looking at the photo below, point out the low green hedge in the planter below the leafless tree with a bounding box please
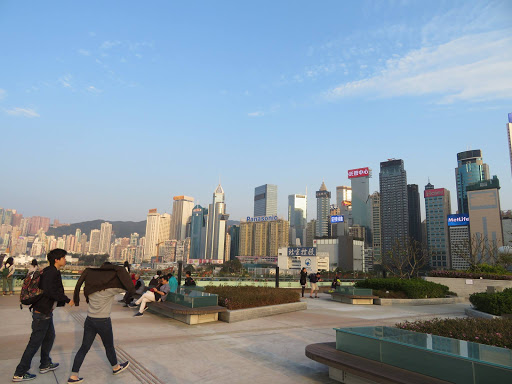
[355,278,449,299]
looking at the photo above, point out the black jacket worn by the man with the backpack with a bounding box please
[32,265,71,316]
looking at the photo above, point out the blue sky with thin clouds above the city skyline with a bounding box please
[0,0,512,223]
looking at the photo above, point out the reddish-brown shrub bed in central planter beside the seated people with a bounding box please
[205,285,300,309]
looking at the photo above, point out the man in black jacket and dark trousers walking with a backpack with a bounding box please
[12,248,74,382]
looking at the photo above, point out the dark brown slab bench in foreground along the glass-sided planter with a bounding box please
[306,342,449,384]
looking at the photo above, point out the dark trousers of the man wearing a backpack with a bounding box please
[14,312,55,376]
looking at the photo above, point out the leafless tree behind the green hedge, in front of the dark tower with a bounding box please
[382,237,430,279]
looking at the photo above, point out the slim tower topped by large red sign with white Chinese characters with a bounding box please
[348,167,372,240]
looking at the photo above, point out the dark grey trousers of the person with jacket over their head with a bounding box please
[71,316,117,376]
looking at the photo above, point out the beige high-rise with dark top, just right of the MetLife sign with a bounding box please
[467,176,503,261]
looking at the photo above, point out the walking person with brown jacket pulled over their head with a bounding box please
[68,262,135,384]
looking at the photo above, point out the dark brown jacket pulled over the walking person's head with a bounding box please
[73,263,135,307]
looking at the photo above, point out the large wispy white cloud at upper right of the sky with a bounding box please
[326,29,512,103]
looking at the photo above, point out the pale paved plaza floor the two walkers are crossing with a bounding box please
[0,293,470,384]
